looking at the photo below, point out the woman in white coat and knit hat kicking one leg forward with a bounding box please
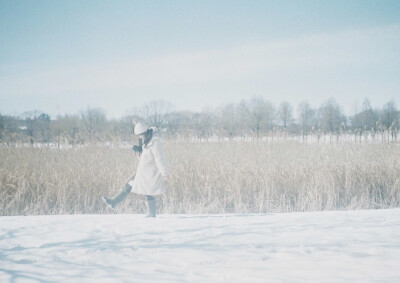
[102,122,168,217]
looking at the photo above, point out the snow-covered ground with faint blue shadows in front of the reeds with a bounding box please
[0,209,400,282]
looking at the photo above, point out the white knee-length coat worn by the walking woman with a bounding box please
[129,135,168,195]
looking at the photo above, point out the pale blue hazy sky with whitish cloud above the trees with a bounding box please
[0,0,400,118]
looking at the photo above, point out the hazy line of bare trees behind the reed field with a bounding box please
[0,97,400,146]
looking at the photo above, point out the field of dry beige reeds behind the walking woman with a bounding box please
[0,142,400,215]
